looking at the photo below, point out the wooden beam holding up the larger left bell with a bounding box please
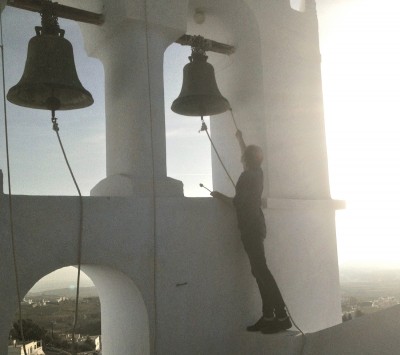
[7,0,104,25]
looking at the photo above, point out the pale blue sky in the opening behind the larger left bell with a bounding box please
[0,6,105,195]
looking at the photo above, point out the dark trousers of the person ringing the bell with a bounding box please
[241,232,286,317]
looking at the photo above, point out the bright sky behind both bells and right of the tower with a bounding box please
[0,0,400,292]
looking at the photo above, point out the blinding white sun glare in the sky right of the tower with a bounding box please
[320,0,400,266]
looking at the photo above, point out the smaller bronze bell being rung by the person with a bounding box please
[171,52,230,116]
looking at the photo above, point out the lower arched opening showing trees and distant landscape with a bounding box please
[10,267,101,354]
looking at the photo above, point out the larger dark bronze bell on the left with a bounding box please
[7,23,93,111]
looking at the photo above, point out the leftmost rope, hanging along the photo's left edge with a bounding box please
[0,10,27,355]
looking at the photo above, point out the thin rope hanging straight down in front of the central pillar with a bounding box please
[144,0,158,355]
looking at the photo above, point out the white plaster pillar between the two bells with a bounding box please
[76,0,186,196]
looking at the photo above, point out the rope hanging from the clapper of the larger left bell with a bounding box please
[51,111,83,355]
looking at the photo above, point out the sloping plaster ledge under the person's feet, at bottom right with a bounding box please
[231,306,400,355]
